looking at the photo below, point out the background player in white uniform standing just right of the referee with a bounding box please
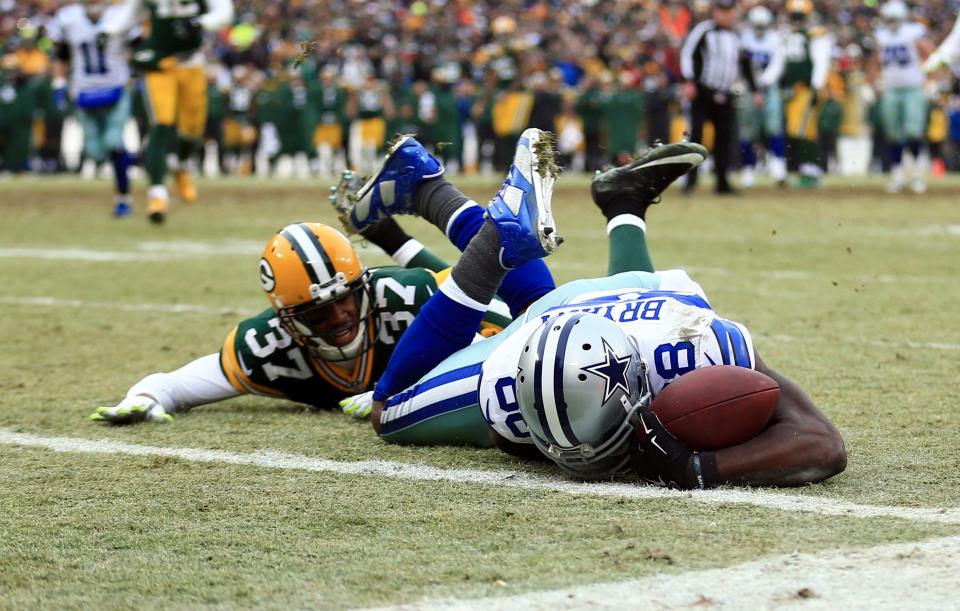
[740,5,787,187]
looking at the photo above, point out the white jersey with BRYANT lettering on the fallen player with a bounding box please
[479,281,756,443]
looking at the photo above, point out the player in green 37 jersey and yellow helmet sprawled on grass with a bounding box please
[90,216,510,424]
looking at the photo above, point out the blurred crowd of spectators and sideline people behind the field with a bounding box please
[0,0,960,179]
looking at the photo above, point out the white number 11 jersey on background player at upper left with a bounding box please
[55,4,130,99]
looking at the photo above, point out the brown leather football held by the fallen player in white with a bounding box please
[650,365,780,450]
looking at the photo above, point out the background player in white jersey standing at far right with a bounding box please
[870,0,933,193]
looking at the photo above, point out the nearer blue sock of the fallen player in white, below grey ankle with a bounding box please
[373,290,484,401]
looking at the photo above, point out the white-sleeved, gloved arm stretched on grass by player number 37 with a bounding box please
[90,353,241,424]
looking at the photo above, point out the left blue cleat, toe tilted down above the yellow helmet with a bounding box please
[341,135,443,233]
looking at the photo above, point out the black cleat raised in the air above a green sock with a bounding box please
[590,142,707,218]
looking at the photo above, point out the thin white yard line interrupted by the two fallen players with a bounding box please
[7,295,960,350]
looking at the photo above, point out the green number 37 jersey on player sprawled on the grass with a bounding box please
[220,266,503,408]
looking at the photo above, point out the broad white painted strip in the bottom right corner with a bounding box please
[372,536,960,611]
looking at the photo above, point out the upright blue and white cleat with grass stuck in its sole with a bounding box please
[487,128,563,269]
